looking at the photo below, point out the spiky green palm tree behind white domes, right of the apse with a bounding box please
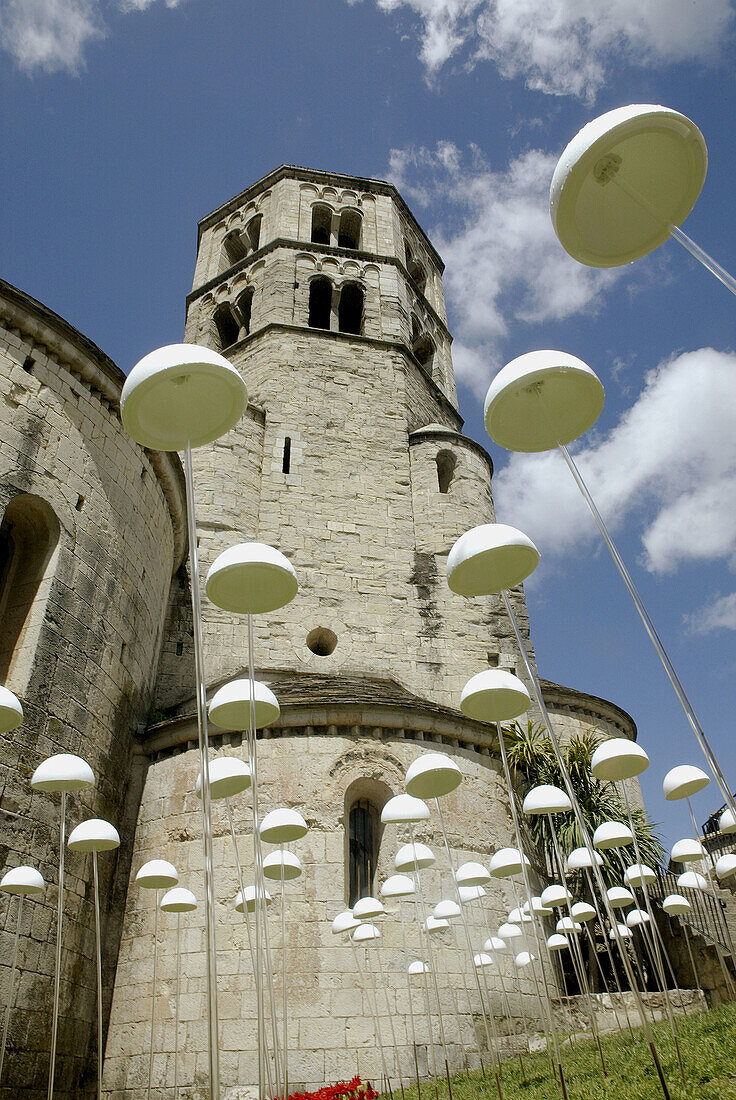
[503,722,664,886]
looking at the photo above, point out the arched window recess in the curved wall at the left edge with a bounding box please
[0,493,61,690]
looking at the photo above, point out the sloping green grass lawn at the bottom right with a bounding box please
[384,1004,736,1100]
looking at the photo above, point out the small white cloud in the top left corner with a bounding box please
[0,0,101,73]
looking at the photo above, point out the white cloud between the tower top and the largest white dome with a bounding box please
[389,142,620,396]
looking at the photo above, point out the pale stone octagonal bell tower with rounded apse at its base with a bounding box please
[106,166,631,1095]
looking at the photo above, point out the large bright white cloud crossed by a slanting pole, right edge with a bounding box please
[494,348,736,573]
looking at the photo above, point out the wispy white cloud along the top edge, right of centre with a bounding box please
[365,0,734,100]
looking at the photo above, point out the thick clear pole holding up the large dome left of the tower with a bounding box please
[182,443,220,1100]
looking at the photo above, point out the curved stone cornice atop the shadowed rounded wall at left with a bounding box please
[0,279,186,571]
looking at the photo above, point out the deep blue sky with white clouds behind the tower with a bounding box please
[0,0,736,840]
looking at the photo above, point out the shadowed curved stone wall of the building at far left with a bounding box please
[0,284,184,1096]
